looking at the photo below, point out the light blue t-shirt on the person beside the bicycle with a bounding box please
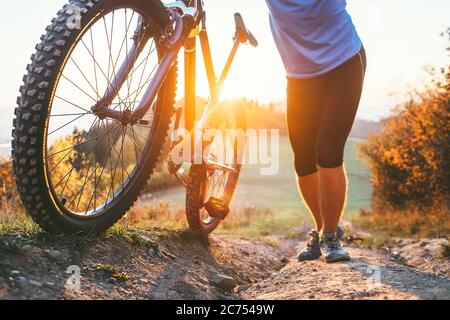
[266,0,362,78]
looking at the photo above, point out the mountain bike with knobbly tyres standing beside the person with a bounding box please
[12,0,258,235]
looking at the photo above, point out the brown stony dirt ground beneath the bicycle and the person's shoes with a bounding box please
[0,230,450,300]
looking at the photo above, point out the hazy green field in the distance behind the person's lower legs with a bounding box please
[146,137,371,219]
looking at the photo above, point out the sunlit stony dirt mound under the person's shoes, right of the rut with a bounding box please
[241,242,450,299]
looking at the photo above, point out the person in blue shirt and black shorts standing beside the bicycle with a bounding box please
[266,0,366,262]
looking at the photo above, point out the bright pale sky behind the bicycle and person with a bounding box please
[0,0,450,120]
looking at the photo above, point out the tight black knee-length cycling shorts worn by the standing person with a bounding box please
[287,49,366,176]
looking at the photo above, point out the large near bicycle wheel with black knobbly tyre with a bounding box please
[12,0,177,234]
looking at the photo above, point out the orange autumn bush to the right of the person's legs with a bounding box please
[360,32,450,235]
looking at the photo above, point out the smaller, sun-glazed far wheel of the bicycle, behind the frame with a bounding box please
[186,105,246,237]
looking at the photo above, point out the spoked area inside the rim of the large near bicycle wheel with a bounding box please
[45,8,160,216]
